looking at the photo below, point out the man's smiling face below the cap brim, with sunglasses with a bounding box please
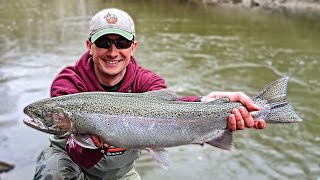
[87,34,137,79]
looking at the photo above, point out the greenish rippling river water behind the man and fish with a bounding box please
[0,0,320,180]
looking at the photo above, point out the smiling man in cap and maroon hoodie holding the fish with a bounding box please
[34,9,265,179]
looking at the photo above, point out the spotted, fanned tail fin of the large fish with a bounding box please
[253,77,302,123]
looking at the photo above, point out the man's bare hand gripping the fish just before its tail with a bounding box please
[201,92,266,131]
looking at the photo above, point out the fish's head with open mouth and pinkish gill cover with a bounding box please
[23,101,73,135]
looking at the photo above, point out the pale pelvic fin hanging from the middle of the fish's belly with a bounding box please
[147,148,169,170]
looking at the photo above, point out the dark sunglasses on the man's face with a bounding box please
[94,38,133,49]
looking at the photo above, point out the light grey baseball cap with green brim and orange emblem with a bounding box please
[89,8,135,42]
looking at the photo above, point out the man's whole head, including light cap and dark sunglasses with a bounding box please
[87,10,137,86]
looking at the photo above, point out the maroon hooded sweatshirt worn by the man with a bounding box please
[51,52,199,169]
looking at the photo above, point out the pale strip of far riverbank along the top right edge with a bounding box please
[186,0,320,16]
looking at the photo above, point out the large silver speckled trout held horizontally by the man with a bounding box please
[24,77,301,167]
